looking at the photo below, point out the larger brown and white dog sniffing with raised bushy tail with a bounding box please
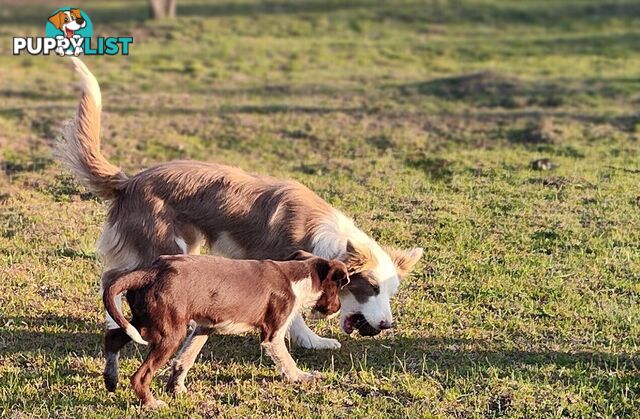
[57,58,422,394]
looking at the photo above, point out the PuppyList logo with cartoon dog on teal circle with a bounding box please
[13,7,133,57]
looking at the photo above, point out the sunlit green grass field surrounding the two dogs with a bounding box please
[0,0,640,418]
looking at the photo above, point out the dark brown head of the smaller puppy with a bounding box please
[291,250,349,317]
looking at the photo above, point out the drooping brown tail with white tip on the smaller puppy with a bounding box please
[102,268,157,345]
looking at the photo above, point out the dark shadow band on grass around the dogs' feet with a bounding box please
[0,315,640,388]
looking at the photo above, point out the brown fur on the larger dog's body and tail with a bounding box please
[57,58,424,394]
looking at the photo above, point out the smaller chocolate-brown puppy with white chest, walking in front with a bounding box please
[103,252,349,408]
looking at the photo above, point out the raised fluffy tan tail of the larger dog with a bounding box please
[55,57,127,199]
